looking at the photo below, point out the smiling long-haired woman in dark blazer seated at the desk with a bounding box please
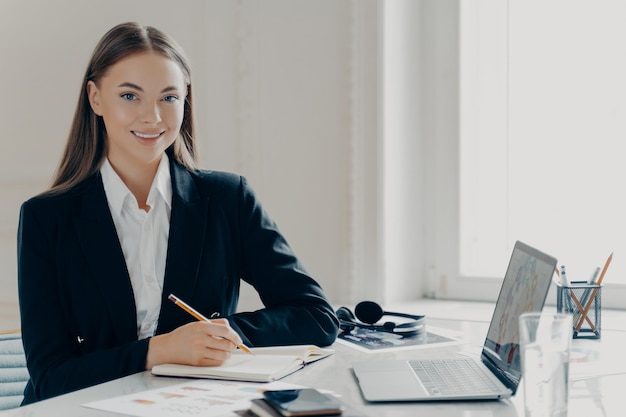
[18,23,338,403]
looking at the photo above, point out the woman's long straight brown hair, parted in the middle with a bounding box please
[48,22,196,193]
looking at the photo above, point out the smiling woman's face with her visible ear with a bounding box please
[87,52,187,170]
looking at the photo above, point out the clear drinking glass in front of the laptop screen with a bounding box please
[519,313,573,417]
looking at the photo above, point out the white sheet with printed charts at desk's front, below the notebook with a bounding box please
[83,380,302,417]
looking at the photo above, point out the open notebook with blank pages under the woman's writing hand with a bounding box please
[152,345,335,382]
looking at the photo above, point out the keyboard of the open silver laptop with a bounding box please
[409,358,497,395]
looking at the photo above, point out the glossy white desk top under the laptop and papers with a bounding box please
[0,301,626,417]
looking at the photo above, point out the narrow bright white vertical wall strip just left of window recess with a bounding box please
[382,0,424,299]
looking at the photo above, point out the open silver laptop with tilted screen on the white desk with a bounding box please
[352,241,557,402]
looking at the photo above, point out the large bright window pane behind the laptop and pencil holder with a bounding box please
[447,0,626,305]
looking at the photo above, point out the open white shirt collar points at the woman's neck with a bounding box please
[100,153,172,214]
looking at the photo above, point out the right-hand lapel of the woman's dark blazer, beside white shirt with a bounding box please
[159,162,209,318]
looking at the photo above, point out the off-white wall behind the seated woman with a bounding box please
[0,0,398,324]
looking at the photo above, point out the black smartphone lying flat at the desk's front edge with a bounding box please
[263,388,343,417]
